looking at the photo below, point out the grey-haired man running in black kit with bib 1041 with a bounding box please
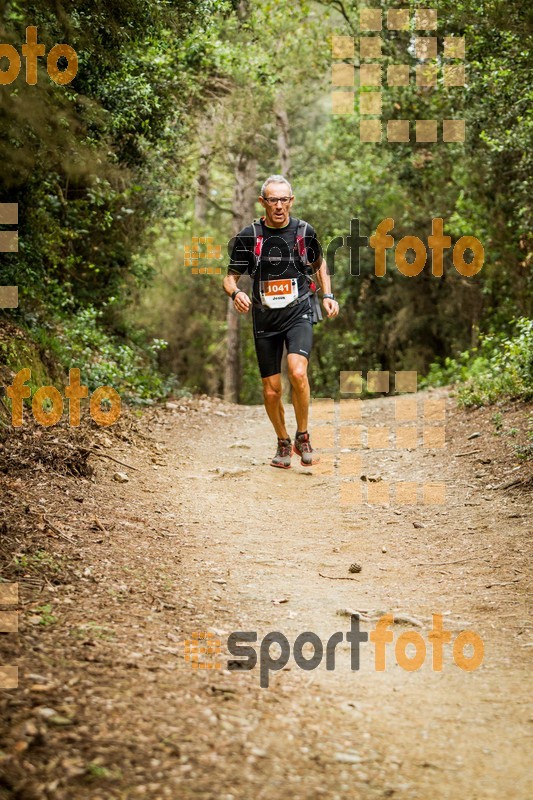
[224,175,339,469]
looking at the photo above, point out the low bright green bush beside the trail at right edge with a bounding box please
[423,318,533,406]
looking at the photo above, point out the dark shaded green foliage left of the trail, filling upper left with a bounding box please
[0,0,232,402]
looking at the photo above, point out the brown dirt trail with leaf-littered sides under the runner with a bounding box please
[0,390,533,800]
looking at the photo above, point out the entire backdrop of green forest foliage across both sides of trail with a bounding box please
[0,0,533,403]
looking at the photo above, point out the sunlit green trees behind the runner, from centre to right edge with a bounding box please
[129,0,533,402]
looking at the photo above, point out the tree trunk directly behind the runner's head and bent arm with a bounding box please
[224,153,257,403]
